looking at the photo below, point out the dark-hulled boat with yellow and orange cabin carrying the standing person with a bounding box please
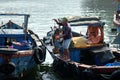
[44,17,120,80]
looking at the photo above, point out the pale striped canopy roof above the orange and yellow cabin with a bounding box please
[58,16,105,27]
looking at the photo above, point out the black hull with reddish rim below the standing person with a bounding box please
[53,57,120,80]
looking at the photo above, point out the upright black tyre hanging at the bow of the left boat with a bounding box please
[33,47,45,64]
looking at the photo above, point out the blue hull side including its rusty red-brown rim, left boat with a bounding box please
[0,50,36,76]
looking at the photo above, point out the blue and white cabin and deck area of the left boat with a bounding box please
[0,14,33,50]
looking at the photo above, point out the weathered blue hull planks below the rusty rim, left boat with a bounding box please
[0,56,37,78]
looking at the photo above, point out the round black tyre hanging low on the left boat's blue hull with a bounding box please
[0,62,16,74]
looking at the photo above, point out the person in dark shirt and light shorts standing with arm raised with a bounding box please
[53,17,72,60]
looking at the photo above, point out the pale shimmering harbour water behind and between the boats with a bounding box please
[0,0,118,80]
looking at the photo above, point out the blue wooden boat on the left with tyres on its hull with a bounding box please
[0,13,46,80]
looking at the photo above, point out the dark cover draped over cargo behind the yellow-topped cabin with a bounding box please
[91,47,115,65]
